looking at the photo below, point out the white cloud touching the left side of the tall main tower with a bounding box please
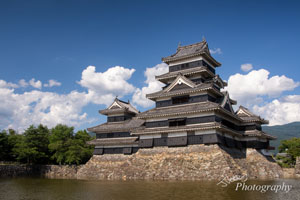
[132,63,168,108]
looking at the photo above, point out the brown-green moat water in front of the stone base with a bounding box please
[0,178,300,200]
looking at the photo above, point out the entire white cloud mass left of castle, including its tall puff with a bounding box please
[0,66,135,131]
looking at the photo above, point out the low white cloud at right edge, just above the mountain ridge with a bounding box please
[253,95,300,125]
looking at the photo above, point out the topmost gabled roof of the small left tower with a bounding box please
[99,98,139,115]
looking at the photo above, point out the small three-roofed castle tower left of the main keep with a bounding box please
[88,98,144,155]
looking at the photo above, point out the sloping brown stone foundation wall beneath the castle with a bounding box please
[77,145,283,180]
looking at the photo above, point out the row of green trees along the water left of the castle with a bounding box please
[0,124,93,164]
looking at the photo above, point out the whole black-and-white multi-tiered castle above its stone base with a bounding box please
[88,40,276,155]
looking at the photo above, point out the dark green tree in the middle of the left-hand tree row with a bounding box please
[14,125,49,164]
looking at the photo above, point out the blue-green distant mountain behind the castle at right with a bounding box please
[262,122,300,153]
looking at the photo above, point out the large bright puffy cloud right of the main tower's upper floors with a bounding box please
[225,69,299,107]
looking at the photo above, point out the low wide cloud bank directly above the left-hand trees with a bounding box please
[0,88,89,131]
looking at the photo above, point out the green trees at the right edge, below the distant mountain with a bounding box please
[277,138,300,167]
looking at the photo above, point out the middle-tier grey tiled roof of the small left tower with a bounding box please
[88,118,144,133]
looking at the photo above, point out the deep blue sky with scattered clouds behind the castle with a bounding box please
[0,0,300,132]
